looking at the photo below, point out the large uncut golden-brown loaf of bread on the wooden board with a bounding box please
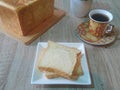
[0,0,54,36]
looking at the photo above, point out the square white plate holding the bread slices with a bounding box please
[31,42,92,85]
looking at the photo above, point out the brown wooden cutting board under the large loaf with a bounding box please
[0,9,65,45]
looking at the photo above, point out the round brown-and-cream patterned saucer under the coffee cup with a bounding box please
[75,22,116,45]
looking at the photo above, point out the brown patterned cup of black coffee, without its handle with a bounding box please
[89,9,113,38]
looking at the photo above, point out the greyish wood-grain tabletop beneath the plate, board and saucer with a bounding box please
[0,0,120,90]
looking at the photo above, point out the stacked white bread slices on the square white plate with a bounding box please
[37,41,83,80]
